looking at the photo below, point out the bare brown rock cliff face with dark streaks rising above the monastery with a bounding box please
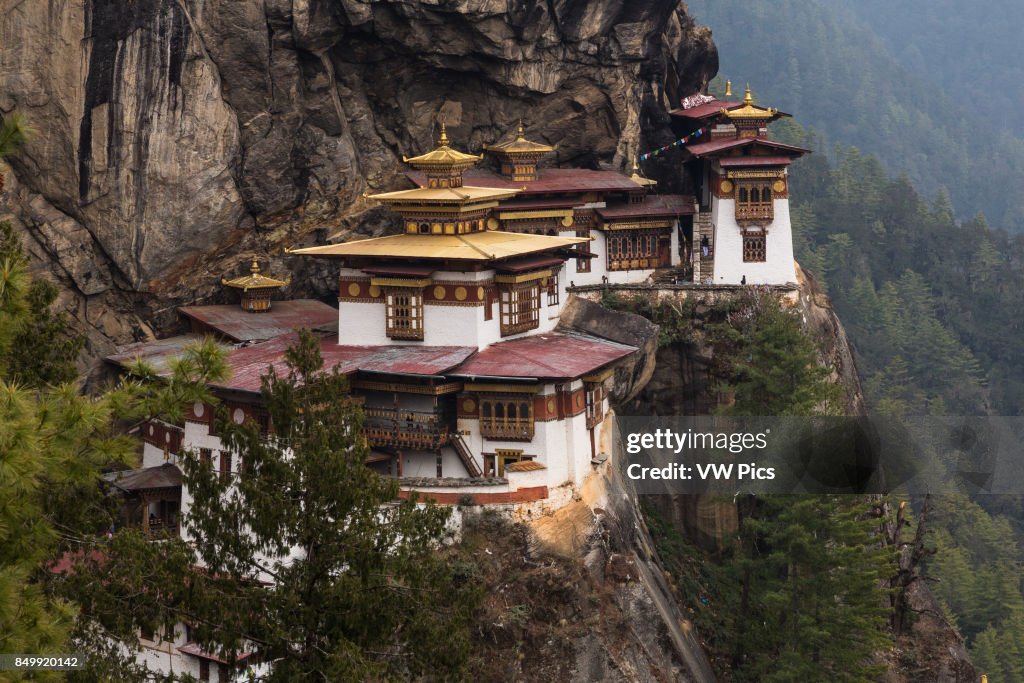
[0,0,718,374]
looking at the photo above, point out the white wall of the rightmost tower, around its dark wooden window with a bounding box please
[711,197,797,285]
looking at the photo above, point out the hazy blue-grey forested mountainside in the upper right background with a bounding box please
[687,0,1024,232]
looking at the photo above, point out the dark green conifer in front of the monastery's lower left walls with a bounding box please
[78,331,478,681]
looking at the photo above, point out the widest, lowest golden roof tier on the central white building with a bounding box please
[289,230,590,261]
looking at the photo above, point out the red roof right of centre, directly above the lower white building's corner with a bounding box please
[450,332,637,380]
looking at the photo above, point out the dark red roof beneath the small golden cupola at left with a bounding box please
[178,299,338,342]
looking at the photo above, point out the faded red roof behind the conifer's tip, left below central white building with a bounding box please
[218,334,476,393]
